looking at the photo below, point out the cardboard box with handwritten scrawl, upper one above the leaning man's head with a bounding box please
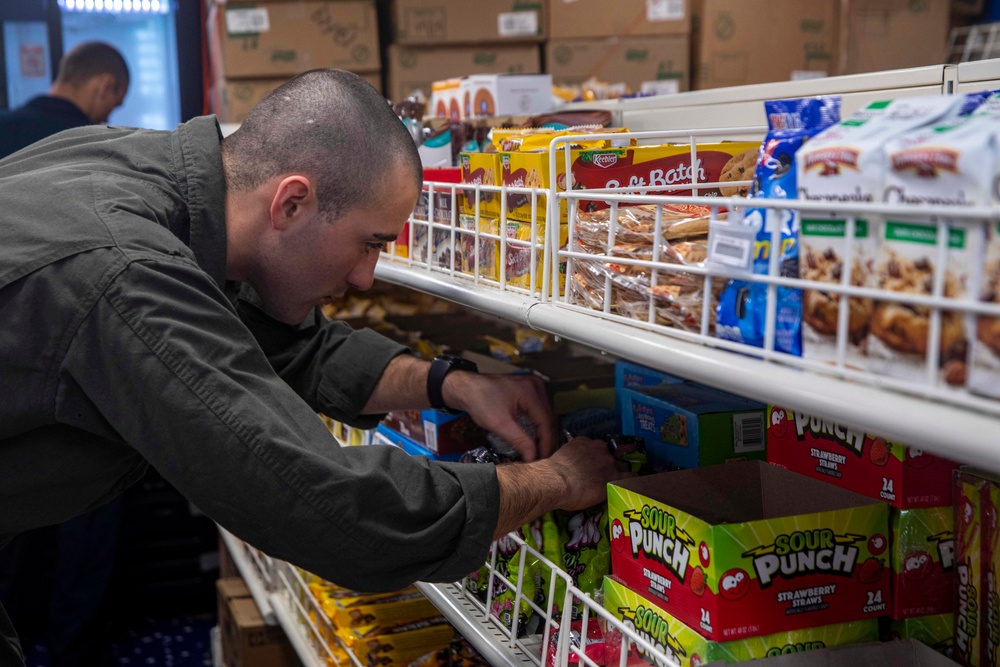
[209,0,381,79]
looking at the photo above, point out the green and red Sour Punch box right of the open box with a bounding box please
[889,505,955,619]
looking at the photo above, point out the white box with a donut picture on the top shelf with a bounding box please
[460,74,552,118]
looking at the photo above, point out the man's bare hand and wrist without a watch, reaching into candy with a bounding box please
[493,438,635,539]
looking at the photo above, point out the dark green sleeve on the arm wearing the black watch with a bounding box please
[236,284,407,428]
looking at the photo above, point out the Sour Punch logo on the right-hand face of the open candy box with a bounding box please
[743,528,865,588]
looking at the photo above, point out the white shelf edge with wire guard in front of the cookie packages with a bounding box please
[376,151,1000,471]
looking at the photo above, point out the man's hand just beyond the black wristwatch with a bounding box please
[442,371,556,461]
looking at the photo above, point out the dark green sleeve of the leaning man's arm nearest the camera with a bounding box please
[57,260,499,590]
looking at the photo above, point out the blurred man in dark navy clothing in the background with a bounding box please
[0,37,129,667]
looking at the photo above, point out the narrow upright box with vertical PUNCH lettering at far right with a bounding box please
[955,469,990,667]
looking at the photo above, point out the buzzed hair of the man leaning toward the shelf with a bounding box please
[222,69,423,221]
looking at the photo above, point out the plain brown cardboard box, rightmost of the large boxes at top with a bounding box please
[837,0,949,74]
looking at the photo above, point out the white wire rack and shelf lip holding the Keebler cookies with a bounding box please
[376,127,1000,471]
